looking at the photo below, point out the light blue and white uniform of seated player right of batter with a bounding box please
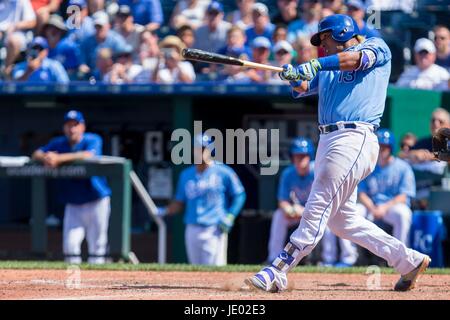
[358,158,416,244]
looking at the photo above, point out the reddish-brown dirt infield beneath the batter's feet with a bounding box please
[0,270,450,300]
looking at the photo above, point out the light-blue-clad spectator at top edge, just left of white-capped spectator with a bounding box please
[67,0,95,44]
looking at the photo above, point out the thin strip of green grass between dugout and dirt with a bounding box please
[0,261,450,274]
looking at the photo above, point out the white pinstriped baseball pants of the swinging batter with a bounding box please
[273,123,425,274]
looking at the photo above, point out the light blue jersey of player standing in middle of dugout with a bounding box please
[175,162,244,226]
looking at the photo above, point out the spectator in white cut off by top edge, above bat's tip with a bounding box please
[170,0,210,30]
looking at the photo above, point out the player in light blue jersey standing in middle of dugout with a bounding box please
[158,135,246,266]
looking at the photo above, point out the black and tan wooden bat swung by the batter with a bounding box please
[181,48,283,72]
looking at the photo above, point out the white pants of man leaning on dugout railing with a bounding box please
[63,197,111,264]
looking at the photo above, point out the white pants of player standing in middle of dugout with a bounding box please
[185,224,227,266]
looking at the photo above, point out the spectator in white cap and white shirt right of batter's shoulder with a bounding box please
[396,38,450,90]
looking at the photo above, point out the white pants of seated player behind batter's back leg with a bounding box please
[357,203,412,245]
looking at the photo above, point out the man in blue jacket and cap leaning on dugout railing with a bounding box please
[32,110,111,264]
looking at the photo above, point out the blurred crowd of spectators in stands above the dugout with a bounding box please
[0,0,450,90]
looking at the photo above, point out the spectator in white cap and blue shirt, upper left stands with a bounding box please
[80,11,126,74]
